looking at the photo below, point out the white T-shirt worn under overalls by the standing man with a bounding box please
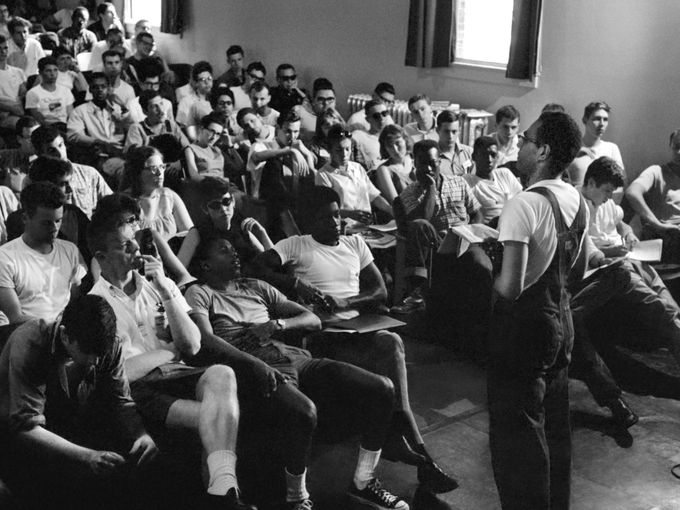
[498,179,588,291]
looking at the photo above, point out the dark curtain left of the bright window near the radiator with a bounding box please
[406,0,456,67]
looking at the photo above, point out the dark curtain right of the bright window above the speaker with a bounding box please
[505,0,542,80]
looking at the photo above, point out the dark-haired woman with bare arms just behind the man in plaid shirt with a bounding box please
[375,124,416,204]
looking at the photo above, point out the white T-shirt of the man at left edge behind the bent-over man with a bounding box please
[0,237,87,322]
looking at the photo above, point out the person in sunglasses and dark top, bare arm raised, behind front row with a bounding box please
[178,177,274,274]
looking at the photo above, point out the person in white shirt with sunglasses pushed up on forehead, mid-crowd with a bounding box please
[315,125,392,228]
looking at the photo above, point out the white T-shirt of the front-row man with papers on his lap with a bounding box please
[274,235,373,316]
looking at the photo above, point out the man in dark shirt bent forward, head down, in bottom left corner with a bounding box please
[0,295,157,509]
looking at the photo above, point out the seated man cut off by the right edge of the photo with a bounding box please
[626,129,680,264]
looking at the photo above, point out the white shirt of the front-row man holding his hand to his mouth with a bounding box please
[90,271,191,360]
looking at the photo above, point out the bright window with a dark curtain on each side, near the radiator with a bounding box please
[454,0,513,69]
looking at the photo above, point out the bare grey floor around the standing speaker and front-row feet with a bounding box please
[309,334,680,510]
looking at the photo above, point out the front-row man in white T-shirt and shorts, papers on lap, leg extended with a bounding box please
[259,187,458,493]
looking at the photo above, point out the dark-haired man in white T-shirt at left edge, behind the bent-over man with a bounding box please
[0,182,86,324]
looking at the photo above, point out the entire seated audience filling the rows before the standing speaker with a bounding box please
[0,0,680,510]
